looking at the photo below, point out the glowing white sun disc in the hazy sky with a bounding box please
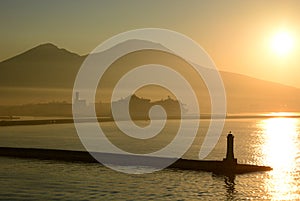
[271,31,295,56]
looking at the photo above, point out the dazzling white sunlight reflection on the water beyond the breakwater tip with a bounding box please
[259,117,300,200]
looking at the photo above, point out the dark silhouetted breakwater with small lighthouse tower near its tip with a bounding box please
[0,133,272,175]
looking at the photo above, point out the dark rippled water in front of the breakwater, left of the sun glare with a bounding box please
[0,158,270,200]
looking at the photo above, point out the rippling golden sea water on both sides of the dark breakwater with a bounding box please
[0,114,300,200]
